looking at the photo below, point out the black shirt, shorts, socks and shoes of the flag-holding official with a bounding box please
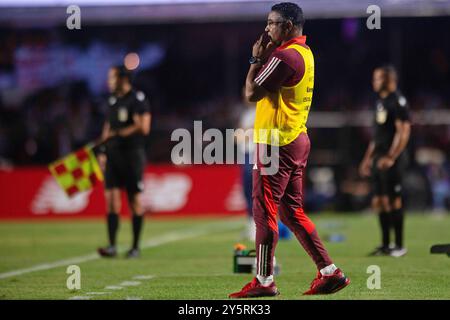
[98,90,151,258]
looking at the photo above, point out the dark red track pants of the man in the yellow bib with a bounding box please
[253,133,332,276]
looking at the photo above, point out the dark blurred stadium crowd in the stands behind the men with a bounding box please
[0,17,450,211]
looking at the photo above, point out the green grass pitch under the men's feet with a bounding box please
[0,214,450,300]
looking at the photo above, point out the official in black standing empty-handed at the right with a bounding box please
[359,66,411,257]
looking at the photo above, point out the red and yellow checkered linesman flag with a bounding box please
[48,144,103,197]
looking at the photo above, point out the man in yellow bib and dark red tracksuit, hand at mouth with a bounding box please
[230,2,350,298]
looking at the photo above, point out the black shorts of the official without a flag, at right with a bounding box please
[372,155,407,199]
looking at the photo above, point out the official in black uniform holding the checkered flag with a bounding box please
[98,66,151,258]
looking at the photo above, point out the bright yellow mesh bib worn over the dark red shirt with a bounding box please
[253,44,314,146]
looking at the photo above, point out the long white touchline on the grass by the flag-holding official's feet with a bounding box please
[0,221,242,279]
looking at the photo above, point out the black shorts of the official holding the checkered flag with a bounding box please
[105,148,145,194]
